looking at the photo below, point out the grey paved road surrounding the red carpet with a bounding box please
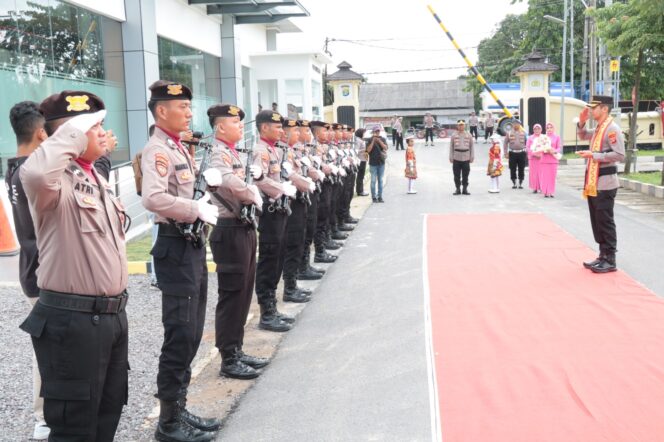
[219,142,664,441]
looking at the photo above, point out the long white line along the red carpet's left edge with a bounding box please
[422,214,443,442]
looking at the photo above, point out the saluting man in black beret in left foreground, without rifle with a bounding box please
[19,91,129,441]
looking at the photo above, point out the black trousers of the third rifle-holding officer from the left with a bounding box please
[256,201,293,305]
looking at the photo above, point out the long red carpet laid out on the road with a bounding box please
[427,214,664,442]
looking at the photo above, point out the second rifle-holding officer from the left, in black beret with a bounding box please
[207,104,268,379]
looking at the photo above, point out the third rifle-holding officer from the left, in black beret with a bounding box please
[253,110,297,332]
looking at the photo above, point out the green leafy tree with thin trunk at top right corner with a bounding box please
[592,0,664,180]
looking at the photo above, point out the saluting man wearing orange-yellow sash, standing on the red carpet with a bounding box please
[576,95,625,273]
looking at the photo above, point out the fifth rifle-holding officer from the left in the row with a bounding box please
[297,120,325,280]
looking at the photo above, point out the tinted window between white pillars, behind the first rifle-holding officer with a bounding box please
[159,37,221,134]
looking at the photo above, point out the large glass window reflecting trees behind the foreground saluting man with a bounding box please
[0,0,129,169]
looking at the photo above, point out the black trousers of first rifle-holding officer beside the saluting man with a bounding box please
[151,231,208,401]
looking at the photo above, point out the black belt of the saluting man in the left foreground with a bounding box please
[39,289,128,314]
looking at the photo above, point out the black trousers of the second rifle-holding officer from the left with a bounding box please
[210,218,256,354]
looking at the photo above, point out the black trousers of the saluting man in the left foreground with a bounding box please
[20,302,129,442]
